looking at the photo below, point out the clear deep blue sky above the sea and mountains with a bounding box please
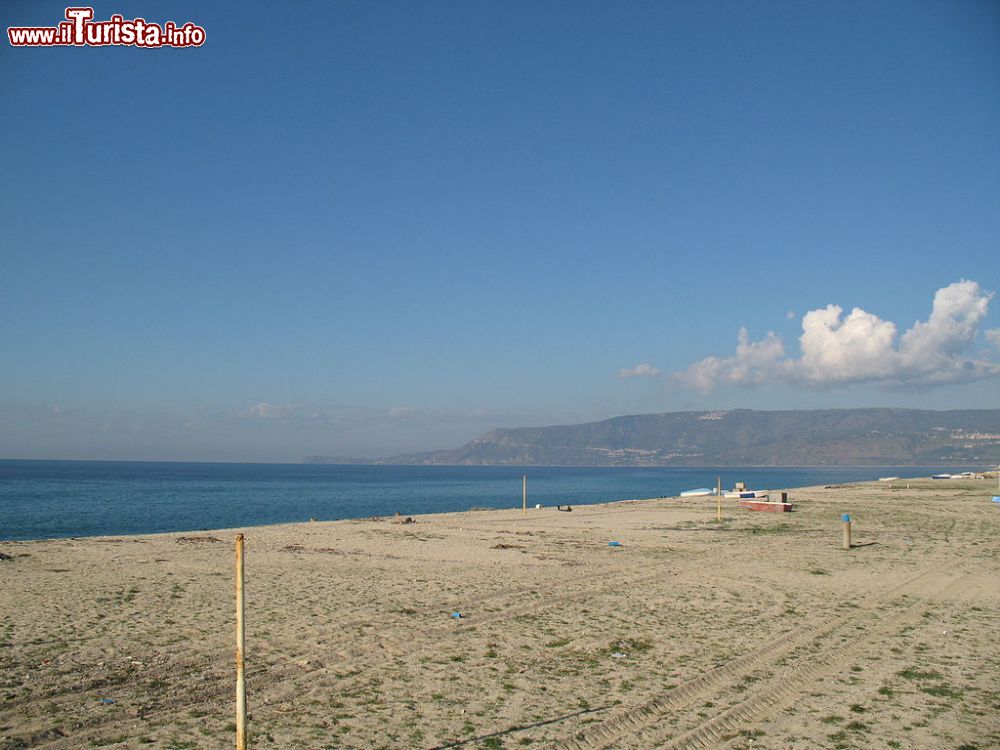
[0,0,1000,461]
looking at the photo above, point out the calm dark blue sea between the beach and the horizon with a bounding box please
[0,460,947,540]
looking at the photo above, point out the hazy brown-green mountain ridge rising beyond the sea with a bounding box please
[309,409,1000,468]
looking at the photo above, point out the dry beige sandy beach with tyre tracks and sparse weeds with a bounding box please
[0,479,1000,750]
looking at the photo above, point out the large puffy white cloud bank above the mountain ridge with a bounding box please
[675,280,1000,391]
